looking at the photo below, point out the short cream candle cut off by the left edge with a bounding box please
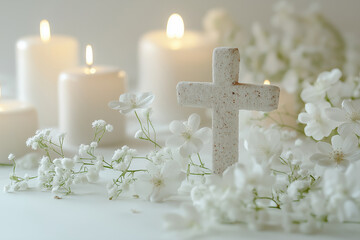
[0,85,38,163]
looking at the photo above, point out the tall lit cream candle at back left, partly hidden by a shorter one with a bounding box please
[16,20,78,127]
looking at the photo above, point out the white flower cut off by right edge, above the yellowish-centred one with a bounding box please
[326,99,360,136]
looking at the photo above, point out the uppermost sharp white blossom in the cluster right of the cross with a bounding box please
[301,68,342,103]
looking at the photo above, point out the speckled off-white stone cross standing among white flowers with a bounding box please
[176,47,280,174]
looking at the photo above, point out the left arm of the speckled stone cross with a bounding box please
[176,82,213,108]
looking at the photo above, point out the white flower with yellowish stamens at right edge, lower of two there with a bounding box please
[310,134,360,168]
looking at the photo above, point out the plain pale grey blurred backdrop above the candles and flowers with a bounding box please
[0,0,360,95]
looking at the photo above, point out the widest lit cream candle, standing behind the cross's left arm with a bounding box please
[138,14,213,123]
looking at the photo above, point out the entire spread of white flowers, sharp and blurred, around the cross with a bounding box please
[5,0,360,236]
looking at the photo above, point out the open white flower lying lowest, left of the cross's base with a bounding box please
[135,161,186,202]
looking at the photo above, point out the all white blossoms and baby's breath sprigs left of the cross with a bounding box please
[5,93,211,202]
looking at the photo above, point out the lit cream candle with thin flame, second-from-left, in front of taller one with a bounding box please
[59,45,126,145]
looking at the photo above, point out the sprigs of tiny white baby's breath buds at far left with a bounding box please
[4,120,113,197]
